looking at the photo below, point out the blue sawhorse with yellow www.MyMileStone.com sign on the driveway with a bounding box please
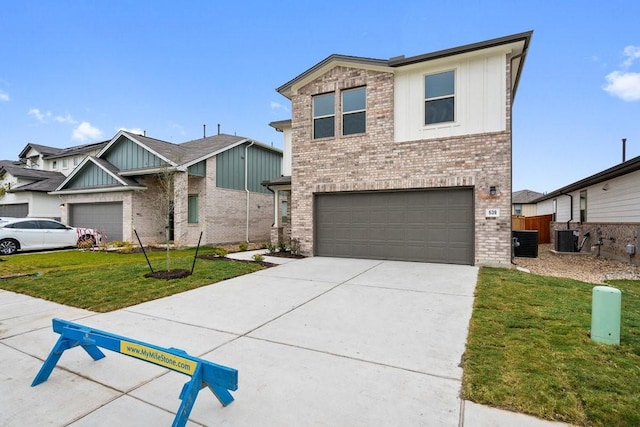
[31,319,238,427]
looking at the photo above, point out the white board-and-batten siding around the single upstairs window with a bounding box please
[394,49,507,142]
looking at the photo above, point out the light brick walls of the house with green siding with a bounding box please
[61,157,273,246]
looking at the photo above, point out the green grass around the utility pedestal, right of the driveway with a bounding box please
[462,268,640,426]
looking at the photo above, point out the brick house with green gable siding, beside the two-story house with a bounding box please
[53,131,282,246]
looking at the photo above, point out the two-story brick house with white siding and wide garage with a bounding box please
[265,32,532,265]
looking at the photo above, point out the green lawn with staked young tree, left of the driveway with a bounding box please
[0,248,263,312]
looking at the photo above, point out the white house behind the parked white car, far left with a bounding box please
[0,142,106,219]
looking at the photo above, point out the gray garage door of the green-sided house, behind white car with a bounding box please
[70,202,122,241]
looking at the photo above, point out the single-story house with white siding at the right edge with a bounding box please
[536,157,640,265]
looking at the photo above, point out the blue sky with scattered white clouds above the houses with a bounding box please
[0,0,640,192]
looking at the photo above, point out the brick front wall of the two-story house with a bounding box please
[291,61,511,265]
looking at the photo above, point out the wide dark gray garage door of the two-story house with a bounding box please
[314,189,474,265]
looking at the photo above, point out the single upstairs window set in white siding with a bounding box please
[424,71,455,125]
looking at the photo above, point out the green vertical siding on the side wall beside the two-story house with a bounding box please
[216,144,282,193]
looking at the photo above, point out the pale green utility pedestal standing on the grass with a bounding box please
[591,286,622,345]
